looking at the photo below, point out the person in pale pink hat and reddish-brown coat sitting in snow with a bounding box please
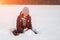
[13,7,37,35]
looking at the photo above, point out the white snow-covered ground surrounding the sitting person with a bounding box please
[0,5,60,40]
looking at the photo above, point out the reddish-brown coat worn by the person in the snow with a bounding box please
[16,13,32,32]
